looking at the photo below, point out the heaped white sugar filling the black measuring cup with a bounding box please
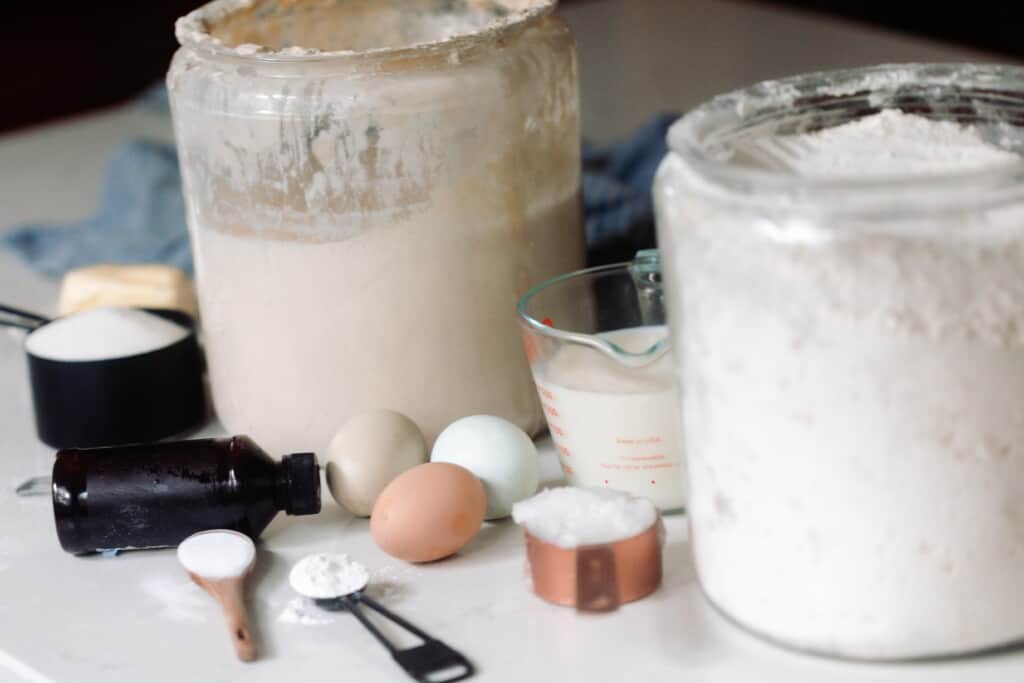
[25,307,188,360]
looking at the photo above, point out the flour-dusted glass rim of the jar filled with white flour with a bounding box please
[669,63,1024,215]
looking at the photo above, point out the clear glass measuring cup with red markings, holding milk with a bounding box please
[518,250,685,510]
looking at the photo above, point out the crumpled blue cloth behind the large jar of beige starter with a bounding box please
[0,109,675,276]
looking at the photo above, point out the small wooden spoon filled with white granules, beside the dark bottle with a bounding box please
[178,529,256,661]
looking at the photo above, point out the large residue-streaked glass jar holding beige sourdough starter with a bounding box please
[167,0,584,452]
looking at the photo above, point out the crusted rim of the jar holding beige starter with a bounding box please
[174,0,558,65]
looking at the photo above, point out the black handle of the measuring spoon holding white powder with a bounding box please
[314,591,476,683]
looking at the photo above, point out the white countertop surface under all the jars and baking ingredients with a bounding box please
[0,0,1024,683]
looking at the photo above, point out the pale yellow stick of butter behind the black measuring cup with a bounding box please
[58,264,197,317]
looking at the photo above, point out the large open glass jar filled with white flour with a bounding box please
[655,66,1024,659]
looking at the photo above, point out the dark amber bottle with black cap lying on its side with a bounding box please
[53,436,321,554]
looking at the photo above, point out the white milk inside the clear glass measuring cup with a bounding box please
[534,325,684,510]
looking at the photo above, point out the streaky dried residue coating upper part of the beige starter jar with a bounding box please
[168,0,579,244]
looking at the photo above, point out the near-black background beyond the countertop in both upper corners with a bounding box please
[0,0,1024,131]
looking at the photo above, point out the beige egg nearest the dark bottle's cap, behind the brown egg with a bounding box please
[326,411,427,517]
